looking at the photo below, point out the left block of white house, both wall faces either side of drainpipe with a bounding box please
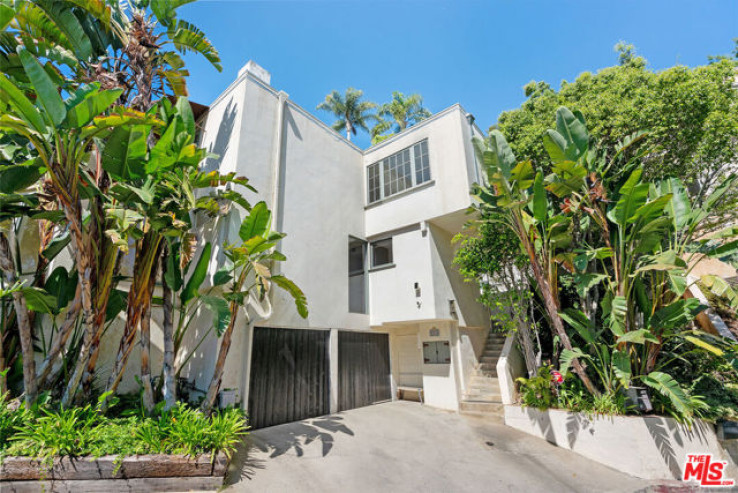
[201,66,369,328]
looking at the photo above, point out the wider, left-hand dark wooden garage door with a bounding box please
[249,327,330,428]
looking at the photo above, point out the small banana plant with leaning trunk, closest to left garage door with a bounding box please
[201,202,308,412]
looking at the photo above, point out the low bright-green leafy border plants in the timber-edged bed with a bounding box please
[0,396,248,465]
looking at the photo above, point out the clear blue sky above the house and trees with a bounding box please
[180,0,738,147]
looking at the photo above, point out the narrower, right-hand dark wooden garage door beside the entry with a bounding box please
[338,331,392,411]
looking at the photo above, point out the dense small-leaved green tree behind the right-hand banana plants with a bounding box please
[490,43,738,220]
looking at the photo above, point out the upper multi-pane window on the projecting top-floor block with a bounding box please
[366,140,430,204]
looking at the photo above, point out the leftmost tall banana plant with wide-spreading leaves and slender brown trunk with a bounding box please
[0,47,158,404]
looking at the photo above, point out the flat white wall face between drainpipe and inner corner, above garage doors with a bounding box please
[269,103,369,329]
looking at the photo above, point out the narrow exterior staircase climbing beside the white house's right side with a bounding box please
[459,330,505,416]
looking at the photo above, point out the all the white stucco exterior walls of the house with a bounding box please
[23,61,484,410]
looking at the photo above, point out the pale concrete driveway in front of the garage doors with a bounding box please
[226,401,678,493]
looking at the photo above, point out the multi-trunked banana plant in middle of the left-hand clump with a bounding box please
[99,98,253,410]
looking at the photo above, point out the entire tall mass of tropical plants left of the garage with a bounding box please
[0,0,307,426]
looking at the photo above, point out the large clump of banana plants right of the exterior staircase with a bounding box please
[468,108,738,419]
